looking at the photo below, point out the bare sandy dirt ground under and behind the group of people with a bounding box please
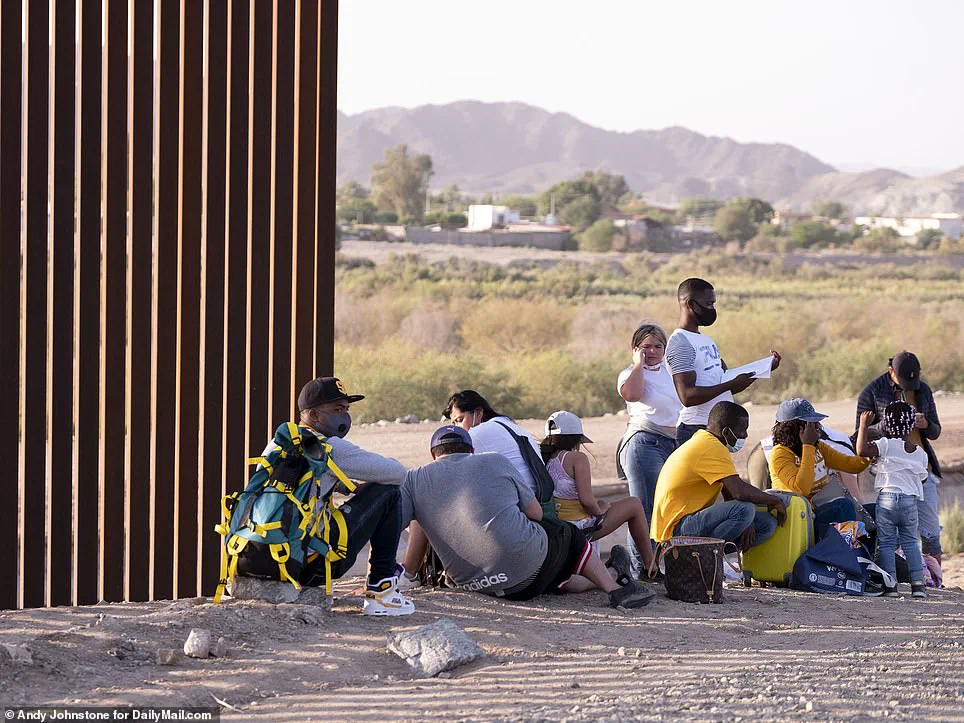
[0,397,964,721]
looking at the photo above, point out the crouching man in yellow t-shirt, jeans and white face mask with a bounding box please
[651,402,786,550]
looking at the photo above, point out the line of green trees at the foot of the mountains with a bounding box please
[335,144,961,252]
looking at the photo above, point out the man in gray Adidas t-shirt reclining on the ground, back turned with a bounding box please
[400,426,654,607]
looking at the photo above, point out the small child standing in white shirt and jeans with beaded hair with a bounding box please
[857,401,927,597]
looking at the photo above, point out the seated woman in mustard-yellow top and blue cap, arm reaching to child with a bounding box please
[770,398,870,537]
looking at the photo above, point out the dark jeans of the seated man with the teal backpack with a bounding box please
[302,484,402,585]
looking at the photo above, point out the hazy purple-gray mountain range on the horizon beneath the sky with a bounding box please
[337,101,964,215]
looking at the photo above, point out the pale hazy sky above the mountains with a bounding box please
[338,0,964,172]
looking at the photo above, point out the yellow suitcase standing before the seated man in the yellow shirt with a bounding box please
[743,490,813,587]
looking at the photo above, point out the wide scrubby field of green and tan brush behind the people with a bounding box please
[335,253,964,428]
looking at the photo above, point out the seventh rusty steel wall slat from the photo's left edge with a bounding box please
[151,2,181,599]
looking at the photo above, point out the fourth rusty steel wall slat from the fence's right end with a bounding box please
[246,2,274,456]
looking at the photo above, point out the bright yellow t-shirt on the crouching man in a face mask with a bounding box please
[650,429,736,542]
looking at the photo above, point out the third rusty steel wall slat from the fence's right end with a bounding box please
[268,0,296,426]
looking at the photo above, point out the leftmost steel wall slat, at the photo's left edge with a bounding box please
[0,2,23,608]
